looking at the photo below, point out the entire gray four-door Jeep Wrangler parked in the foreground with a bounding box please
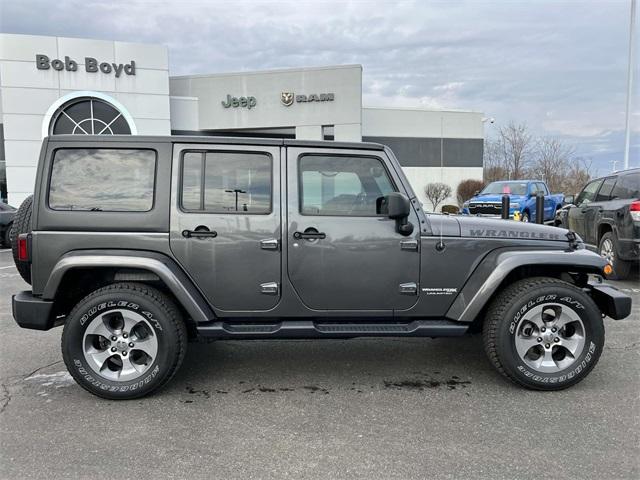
[12,136,631,399]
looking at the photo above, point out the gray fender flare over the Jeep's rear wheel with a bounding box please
[42,250,215,323]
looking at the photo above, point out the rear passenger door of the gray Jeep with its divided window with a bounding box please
[171,145,281,312]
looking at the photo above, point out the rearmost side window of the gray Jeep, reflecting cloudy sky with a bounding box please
[49,148,156,212]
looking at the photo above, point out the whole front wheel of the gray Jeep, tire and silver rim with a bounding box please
[483,277,604,390]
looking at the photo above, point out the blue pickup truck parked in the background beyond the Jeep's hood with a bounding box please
[462,180,564,222]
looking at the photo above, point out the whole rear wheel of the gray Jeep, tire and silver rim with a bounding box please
[62,283,187,400]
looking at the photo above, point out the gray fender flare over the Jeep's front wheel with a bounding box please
[446,248,607,323]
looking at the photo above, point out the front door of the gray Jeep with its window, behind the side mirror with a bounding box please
[287,147,420,311]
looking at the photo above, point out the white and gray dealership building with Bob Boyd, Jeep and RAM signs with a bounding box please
[0,34,484,208]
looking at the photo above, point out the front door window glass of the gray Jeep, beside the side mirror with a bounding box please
[299,155,396,216]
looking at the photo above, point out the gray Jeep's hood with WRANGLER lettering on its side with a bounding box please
[456,215,582,243]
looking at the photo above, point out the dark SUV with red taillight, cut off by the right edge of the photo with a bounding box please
[560,168,640,279]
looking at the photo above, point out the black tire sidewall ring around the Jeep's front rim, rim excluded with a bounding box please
[497,285,604,390]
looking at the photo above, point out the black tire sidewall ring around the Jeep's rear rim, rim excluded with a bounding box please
[62,291,179,398]
